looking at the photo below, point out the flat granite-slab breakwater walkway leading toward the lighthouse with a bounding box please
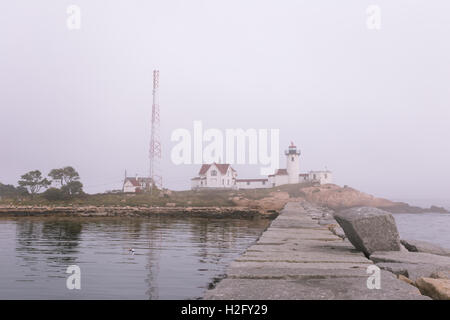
[204,202,430,300]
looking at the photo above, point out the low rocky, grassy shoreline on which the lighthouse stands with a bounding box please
[0,184,450,218]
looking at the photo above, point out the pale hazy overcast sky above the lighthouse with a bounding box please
[0,0,450,206]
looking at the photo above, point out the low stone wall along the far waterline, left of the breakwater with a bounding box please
[0,206,278,218]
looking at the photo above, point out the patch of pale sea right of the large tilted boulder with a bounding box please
[394,213,450,249]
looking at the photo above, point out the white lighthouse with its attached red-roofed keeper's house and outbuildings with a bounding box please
[191,143,332,189]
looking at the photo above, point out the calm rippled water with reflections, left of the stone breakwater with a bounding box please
[0,217,270,299]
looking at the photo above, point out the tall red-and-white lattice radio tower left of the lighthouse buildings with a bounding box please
[150,70,162,191]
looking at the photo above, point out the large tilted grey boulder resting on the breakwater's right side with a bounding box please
[334,207,400,256]
